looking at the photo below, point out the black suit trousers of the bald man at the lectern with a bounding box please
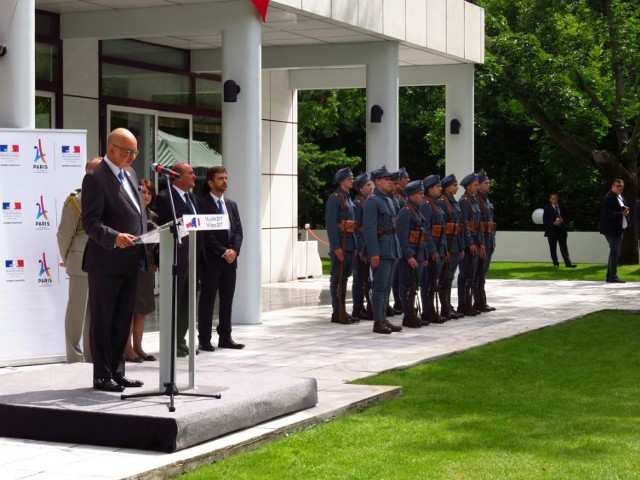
[88,271,138,380]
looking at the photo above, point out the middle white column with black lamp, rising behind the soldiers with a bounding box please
[366,42,399,171]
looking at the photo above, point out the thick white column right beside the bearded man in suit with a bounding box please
[222,2,262,326]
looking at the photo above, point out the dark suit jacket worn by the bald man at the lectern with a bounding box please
[82,160,147,275]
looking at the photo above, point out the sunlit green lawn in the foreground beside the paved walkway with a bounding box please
[176,311,640,480]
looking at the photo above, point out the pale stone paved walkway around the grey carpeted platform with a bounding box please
[0,277,640,480]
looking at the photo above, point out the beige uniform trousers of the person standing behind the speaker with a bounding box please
[64,275,91,363]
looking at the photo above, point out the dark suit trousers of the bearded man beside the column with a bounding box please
[198,258,238,345]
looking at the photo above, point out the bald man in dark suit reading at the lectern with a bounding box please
[82,128,147,392]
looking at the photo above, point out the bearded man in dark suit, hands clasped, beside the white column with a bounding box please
[198,167,244,352]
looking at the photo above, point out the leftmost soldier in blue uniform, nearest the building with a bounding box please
[325,167,357,324]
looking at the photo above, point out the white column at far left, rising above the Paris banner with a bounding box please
[0,0,36,128]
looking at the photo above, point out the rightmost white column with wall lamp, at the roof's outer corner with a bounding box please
[445,64,474,176]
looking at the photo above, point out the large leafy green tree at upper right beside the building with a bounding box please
[478,0,640,263]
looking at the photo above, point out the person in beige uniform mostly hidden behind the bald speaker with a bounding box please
[57,157,101,363]
